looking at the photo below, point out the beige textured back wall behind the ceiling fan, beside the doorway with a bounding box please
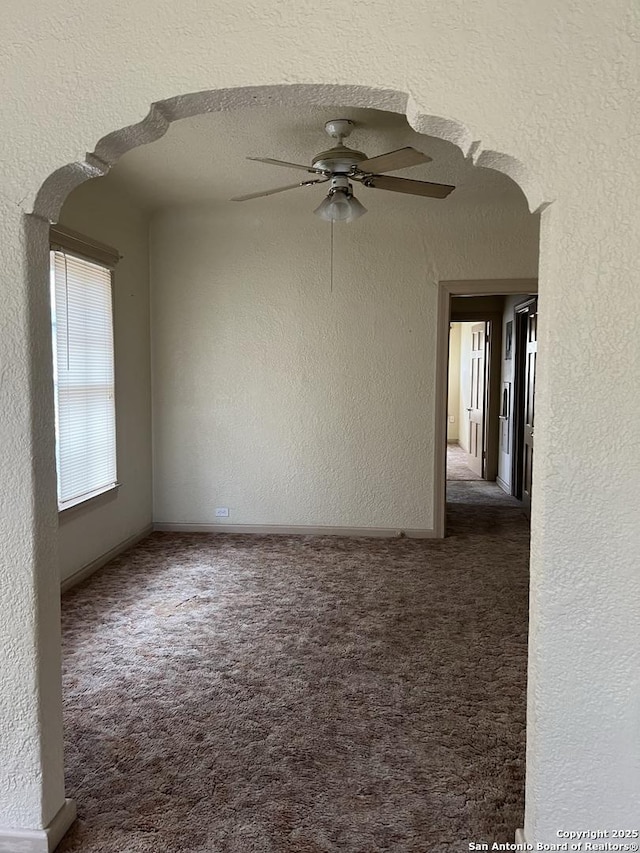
[151,202,538,530]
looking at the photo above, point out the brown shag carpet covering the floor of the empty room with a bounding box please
[59,482,528,853]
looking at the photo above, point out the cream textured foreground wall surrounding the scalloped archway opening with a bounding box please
[0,0,640,841]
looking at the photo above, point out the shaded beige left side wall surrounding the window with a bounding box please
[58,181,151,581]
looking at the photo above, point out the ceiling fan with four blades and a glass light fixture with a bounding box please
[231,119,455,222]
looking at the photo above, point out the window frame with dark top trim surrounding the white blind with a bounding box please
[49,225,122,516]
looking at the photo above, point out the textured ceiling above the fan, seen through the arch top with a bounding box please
[102,107,526,209]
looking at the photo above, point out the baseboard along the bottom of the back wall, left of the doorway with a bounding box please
[153,521,437,539]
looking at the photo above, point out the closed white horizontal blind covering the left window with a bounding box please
[51,250,117,509]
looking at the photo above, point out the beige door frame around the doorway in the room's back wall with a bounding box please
[433,278,538,539]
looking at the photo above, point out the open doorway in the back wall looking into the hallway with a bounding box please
[440,279,537,533]
